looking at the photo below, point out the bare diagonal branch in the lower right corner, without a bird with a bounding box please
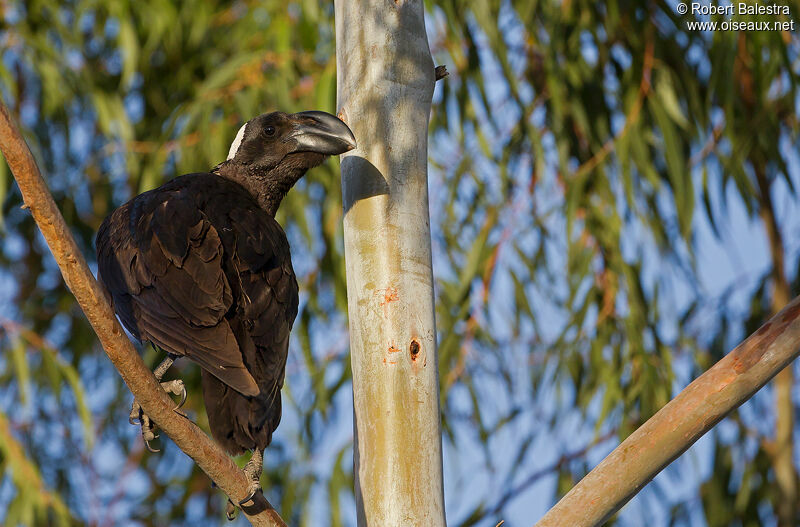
[536,297,800,527]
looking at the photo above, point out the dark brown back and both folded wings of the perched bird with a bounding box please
[97,174,298,404]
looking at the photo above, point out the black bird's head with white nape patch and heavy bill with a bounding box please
[219,111,356,214]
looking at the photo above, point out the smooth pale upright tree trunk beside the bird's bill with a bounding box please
[335,0,445,527]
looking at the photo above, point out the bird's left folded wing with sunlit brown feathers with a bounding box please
[97,177,259,396]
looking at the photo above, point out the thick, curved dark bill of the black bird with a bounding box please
[287,111,356,156]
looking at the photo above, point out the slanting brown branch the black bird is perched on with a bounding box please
[0,102,285,527]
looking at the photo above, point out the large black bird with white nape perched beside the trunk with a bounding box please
[97,111,356,504]
